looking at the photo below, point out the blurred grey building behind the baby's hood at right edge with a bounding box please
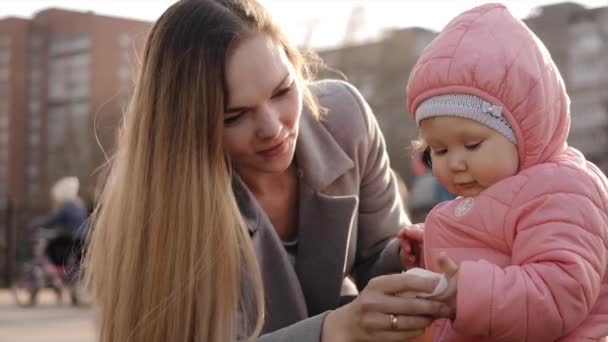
[525,3,608,172]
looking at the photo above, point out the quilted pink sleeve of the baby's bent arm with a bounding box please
[453,193,607,341]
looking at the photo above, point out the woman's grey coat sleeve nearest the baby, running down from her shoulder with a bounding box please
[346,84,410,289]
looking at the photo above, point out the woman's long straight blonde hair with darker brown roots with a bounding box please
[83,0,318,342]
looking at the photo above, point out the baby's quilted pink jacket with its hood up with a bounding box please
[408,4,608,342]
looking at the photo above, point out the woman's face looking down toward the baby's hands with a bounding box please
[224,34,302,176]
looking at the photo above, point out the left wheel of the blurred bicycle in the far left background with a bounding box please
[11,263,45,307]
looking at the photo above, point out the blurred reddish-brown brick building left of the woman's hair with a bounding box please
[0,9,151,207]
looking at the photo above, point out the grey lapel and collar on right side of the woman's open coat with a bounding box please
[296,107,358,315]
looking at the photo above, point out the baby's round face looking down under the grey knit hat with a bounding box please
[420,116,519,197]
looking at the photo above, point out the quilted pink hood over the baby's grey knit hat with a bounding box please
[407,4,570,170]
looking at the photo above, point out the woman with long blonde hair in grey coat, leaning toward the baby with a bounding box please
[86,0,446,341]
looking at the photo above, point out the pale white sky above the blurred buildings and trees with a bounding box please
[0,0,608,48]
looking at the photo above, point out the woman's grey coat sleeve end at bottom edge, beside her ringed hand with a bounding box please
[257,312,329,342]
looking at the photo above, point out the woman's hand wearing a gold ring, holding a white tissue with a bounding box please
[322,274,451,342]
